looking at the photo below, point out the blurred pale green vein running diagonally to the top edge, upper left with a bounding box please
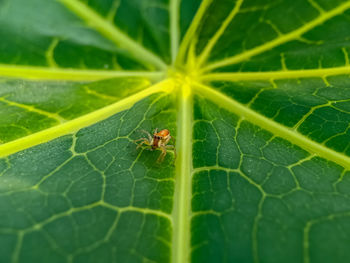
[59,0,167,69]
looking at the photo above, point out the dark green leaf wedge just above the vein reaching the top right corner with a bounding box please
[205,0,318,63]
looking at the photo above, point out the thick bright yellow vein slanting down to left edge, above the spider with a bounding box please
[0,80,174,157]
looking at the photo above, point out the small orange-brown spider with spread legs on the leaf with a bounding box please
[134,128,176,163]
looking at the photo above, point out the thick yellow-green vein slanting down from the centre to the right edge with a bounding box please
[195,83,350,169]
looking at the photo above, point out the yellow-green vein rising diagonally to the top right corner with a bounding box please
[203,1,350,71]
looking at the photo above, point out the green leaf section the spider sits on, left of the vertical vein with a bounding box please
[0,94,176,263]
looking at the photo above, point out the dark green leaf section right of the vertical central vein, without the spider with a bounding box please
[191,98,350,263]
